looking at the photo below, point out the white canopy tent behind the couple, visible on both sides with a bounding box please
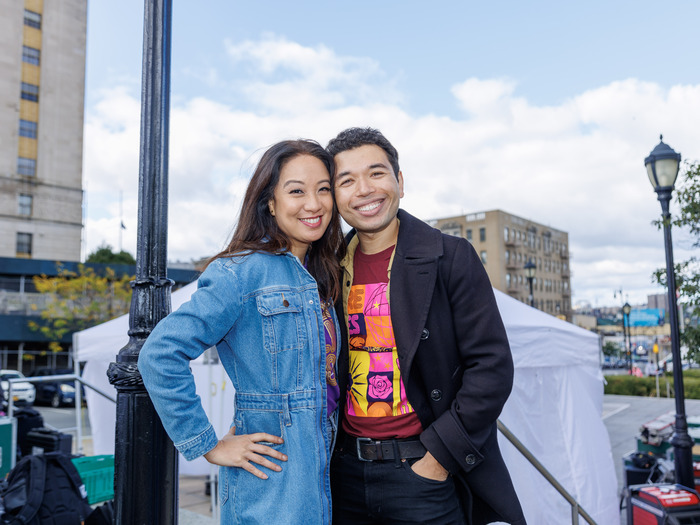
[74,283,619,525]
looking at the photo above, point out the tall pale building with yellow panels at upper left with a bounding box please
[0,0,87,261]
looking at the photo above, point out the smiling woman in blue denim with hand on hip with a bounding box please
[139,140,342,525]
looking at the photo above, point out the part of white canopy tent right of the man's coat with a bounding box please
[495,291,620,525]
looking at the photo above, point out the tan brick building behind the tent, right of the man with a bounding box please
[431,210,572,321]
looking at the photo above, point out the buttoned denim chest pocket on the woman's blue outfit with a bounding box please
[256,292,305,354]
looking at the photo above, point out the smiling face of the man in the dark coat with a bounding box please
[335,145,403,234]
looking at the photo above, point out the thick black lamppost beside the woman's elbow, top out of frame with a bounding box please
[107,0,178,525]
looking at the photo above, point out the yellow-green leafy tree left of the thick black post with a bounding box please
[29,264,133,352]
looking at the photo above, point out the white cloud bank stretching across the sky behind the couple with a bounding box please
[85,36,700,304]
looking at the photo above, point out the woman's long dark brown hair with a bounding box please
[207,139,345,301]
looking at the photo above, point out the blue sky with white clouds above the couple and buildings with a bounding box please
[83,0,700,306]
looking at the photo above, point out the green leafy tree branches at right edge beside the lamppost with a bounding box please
[654,162,700,363]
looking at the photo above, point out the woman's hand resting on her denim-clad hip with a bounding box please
[204,427,287,479]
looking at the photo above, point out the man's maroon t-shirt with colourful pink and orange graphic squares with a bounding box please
[343,246,423,439]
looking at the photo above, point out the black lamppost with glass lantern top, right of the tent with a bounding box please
[644,136,695,488]
